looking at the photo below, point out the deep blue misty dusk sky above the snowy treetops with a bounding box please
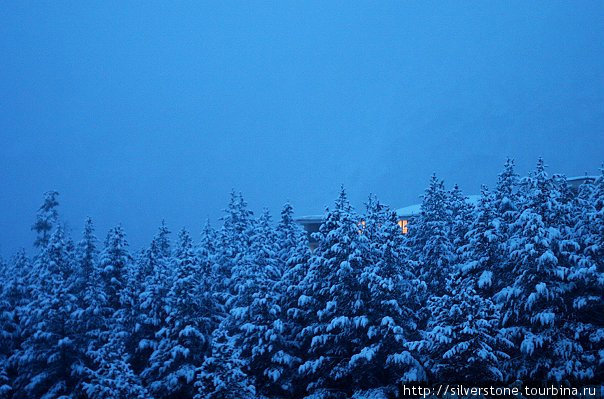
[0,1,604,256]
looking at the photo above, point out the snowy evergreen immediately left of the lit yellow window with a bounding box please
[350,196,426,389]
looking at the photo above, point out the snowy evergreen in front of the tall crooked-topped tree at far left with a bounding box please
[15,227,80,398]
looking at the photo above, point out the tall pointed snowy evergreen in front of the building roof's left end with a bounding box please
[298,188,370,397]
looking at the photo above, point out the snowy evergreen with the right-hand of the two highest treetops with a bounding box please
[496,159,595,383]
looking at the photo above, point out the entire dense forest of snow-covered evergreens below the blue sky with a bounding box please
[0,160,604,399]
